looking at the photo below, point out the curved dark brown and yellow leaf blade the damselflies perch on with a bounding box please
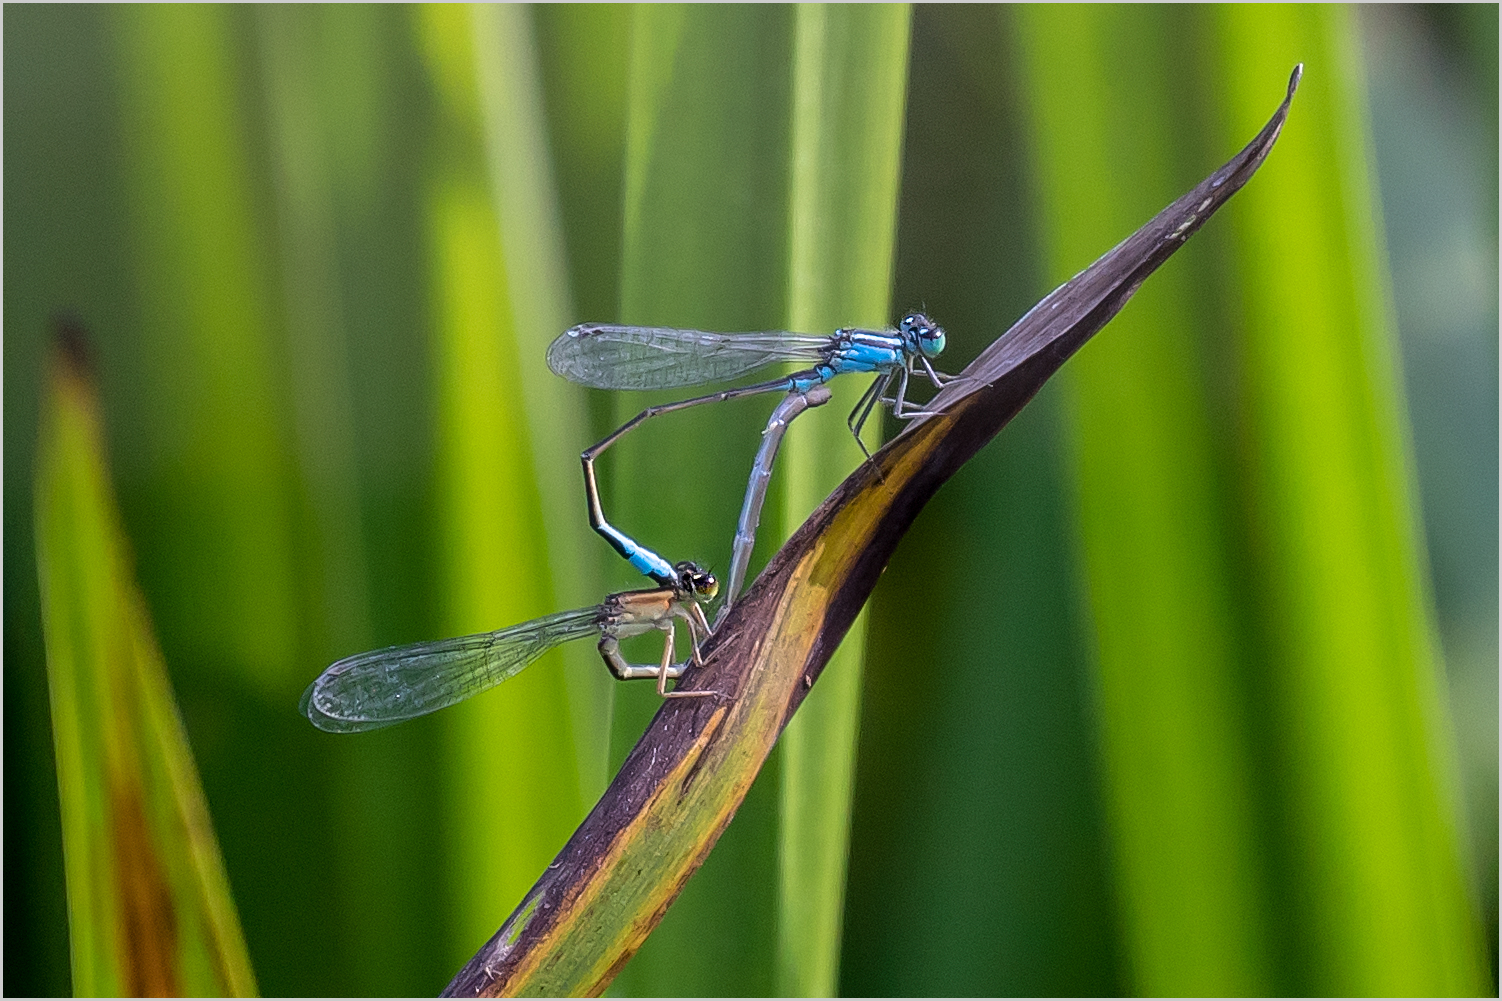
[445,66,1302,996]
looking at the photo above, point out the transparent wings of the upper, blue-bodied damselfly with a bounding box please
[548,323,832,389]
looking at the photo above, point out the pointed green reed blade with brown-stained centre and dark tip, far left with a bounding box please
[36,331,255,996]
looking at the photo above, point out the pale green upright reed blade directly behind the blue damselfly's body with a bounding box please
[774,5,910,996]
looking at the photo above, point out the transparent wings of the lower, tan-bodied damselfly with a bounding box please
[300,606,601,733]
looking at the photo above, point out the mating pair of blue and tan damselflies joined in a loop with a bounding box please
[302,313,949,733]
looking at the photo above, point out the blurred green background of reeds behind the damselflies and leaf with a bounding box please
[5,6,1499,995]
